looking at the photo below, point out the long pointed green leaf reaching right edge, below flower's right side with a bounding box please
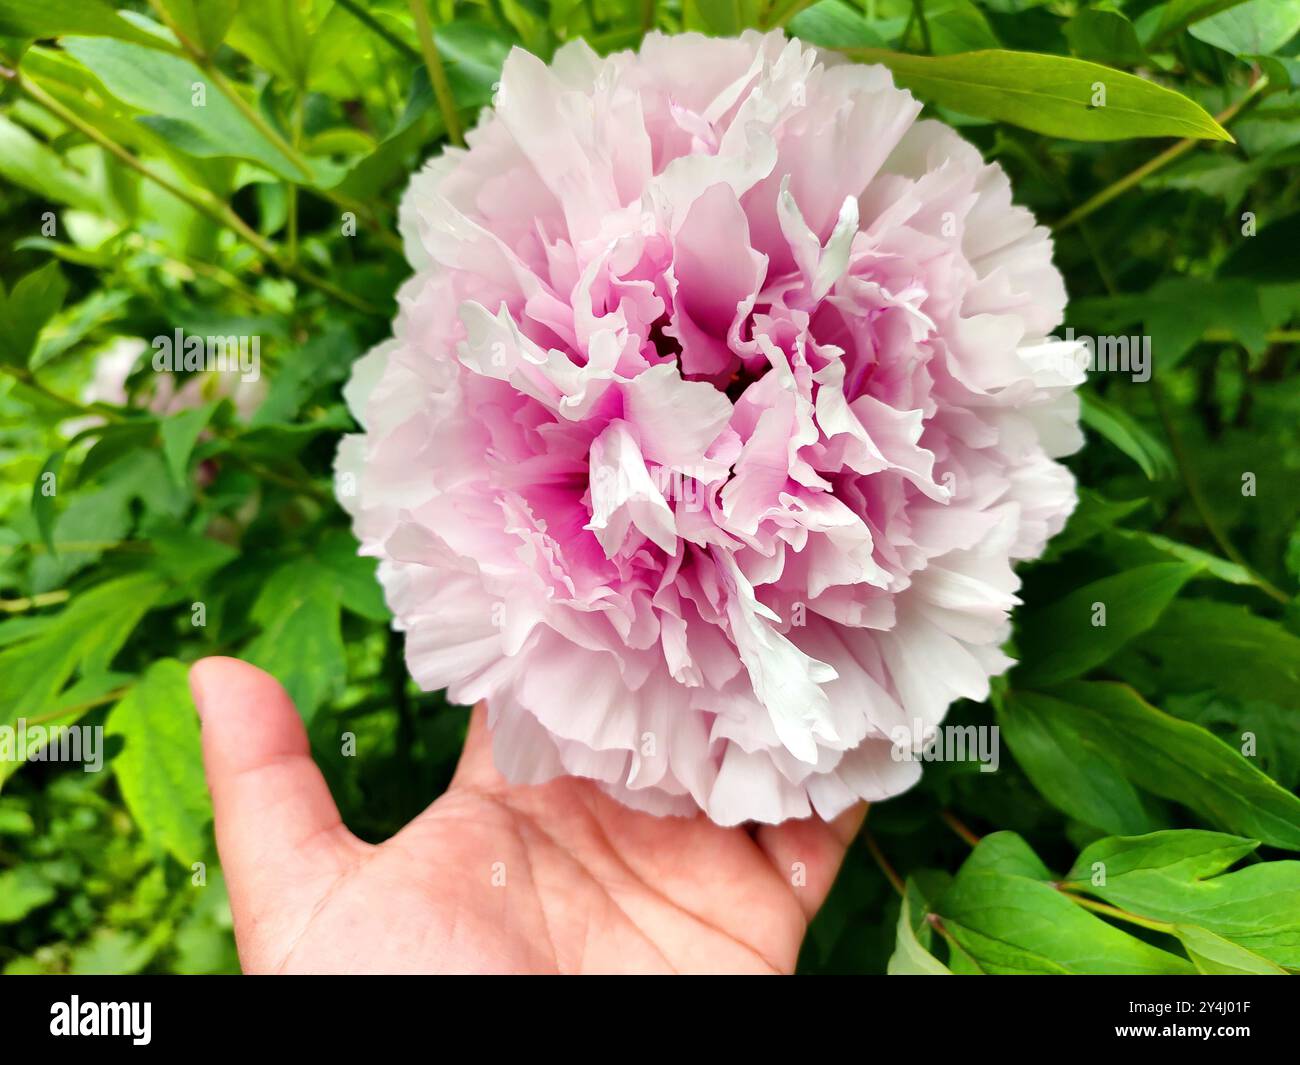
[1008,681,1300,850]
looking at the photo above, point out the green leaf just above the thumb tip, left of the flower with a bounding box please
[246,559,347,723]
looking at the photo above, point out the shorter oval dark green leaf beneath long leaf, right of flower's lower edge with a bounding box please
[995,692,1156,834]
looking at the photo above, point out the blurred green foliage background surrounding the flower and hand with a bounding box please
[0,0,1300,973]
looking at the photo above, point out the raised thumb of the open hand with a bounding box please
[190,658,368,951]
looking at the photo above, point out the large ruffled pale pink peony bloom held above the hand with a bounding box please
[338,25,1082,824]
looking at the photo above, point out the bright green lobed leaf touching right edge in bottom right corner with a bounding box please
[1066,830,1300,969]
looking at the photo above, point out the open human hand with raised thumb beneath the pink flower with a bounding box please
[190,658,863,973]
